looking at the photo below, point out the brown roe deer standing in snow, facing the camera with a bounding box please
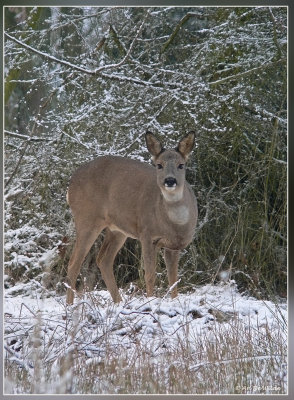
[67,131,198,304]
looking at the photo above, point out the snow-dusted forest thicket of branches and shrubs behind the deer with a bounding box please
[4,7,287,299]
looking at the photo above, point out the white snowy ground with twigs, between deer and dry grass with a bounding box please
[4,282,287,393]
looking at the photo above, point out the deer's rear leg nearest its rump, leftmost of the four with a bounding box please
[66,226,103,304]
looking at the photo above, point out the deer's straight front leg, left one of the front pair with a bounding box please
[141,239,157,297]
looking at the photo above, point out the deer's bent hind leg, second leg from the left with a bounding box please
[96,228,127,303]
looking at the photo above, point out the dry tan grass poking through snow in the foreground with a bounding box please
[5,288,287,394]
